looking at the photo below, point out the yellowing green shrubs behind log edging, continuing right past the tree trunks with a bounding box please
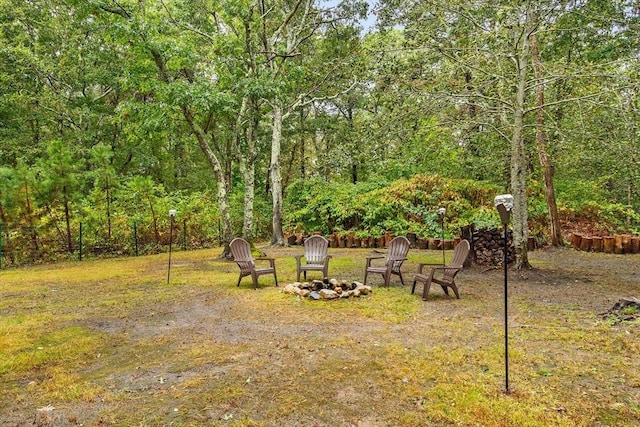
[284,174,629,247]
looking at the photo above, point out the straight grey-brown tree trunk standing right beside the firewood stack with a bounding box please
[511,25,531,270]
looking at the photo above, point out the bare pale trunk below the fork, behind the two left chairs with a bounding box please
[270,105,284,246]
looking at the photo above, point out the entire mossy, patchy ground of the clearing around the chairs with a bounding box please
[0,247,640,427]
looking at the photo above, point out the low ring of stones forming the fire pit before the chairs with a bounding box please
[282,278,372,300]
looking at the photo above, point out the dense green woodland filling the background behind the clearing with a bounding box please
[0,0,640,266]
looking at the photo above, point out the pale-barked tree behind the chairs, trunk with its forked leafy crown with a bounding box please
[246,0,366,245]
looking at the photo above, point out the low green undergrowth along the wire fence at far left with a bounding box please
[0,162,225,264]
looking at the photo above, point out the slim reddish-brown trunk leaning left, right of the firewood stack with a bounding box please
[531,32,563,246]
